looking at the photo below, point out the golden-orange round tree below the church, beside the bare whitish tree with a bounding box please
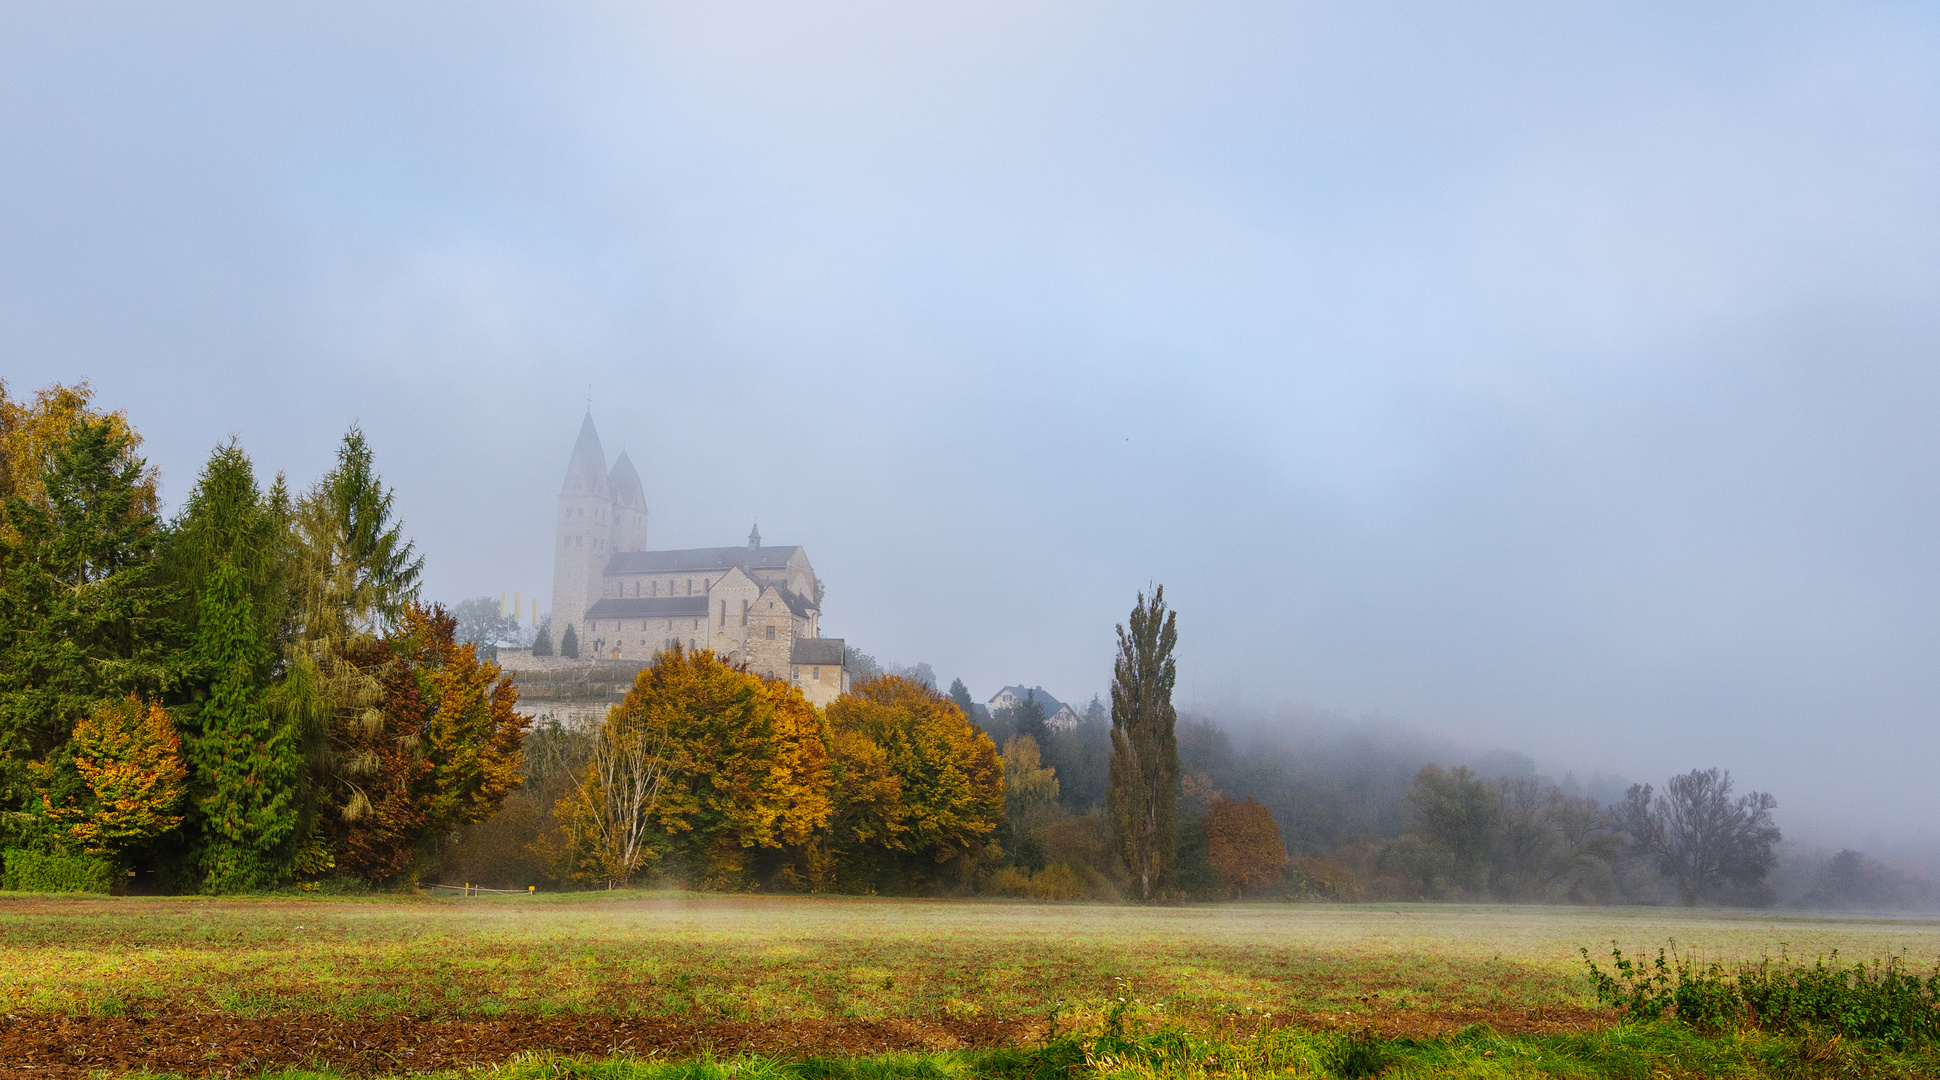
[597,646,830,888]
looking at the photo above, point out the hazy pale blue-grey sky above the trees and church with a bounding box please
[0,0,1940,842]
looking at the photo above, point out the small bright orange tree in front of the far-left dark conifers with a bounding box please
[43,694,188,855]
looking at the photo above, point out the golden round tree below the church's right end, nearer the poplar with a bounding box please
[828,675,1005,886]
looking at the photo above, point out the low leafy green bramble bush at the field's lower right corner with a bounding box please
[1581,942,1940,1047]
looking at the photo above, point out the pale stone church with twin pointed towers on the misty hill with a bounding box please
[551,411,850,706]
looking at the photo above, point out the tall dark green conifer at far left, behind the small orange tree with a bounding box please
[0,413,178,807]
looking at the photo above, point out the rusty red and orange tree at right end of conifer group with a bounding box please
[324,603,528,882]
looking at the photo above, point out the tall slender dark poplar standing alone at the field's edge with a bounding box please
[1106,586,1180,902]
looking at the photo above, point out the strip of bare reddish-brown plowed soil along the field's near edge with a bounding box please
[0,1008,1610,1080]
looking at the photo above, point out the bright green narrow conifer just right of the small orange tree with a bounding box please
[190,558,303,892]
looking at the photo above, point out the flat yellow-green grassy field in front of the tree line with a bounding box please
[0,894,1940,1076]
